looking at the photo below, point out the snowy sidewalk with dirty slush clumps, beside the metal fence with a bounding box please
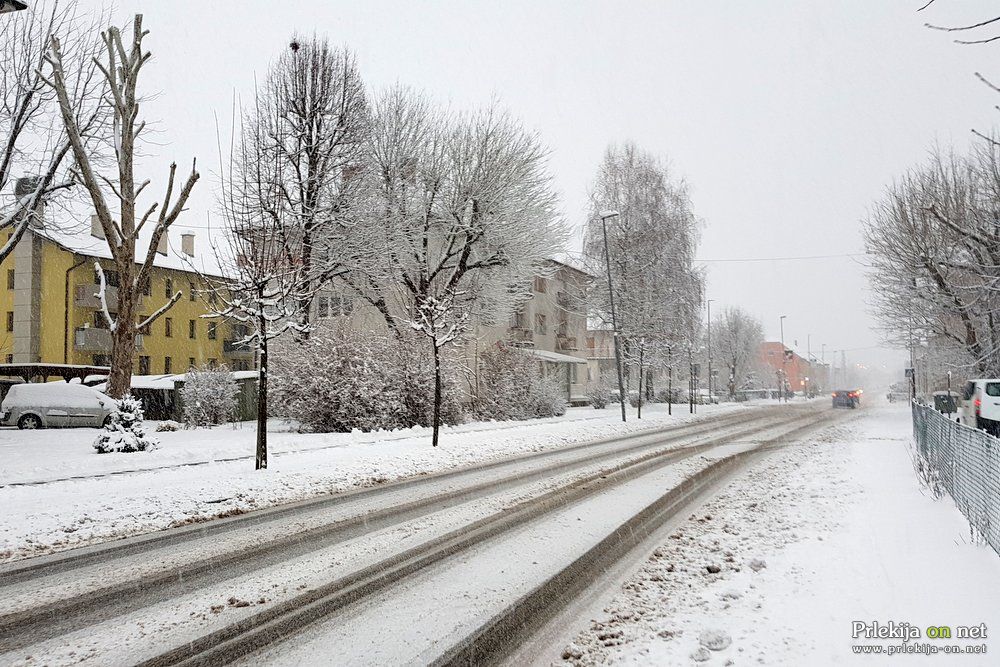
[564,406,1000,667]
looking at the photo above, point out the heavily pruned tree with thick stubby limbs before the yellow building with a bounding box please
[45,15,199,397]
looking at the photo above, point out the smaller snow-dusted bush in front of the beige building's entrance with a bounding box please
[475,344,566,421]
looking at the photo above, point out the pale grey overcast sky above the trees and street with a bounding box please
[76,0,1000,365]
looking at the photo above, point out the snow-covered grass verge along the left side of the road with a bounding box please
[0,404,754,561]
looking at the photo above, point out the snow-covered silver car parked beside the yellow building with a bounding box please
[0,382,116,429]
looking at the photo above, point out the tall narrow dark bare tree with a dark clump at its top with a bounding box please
[255,37,368,335]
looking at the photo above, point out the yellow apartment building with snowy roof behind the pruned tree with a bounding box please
[0,223,254,375]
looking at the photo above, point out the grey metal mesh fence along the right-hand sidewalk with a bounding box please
[912,402,1000,553]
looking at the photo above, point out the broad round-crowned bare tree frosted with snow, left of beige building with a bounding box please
[346,88,565,446]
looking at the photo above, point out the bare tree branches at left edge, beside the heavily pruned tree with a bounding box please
[0,0,105,261]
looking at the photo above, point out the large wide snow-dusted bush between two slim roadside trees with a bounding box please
[271,327,461,432]
